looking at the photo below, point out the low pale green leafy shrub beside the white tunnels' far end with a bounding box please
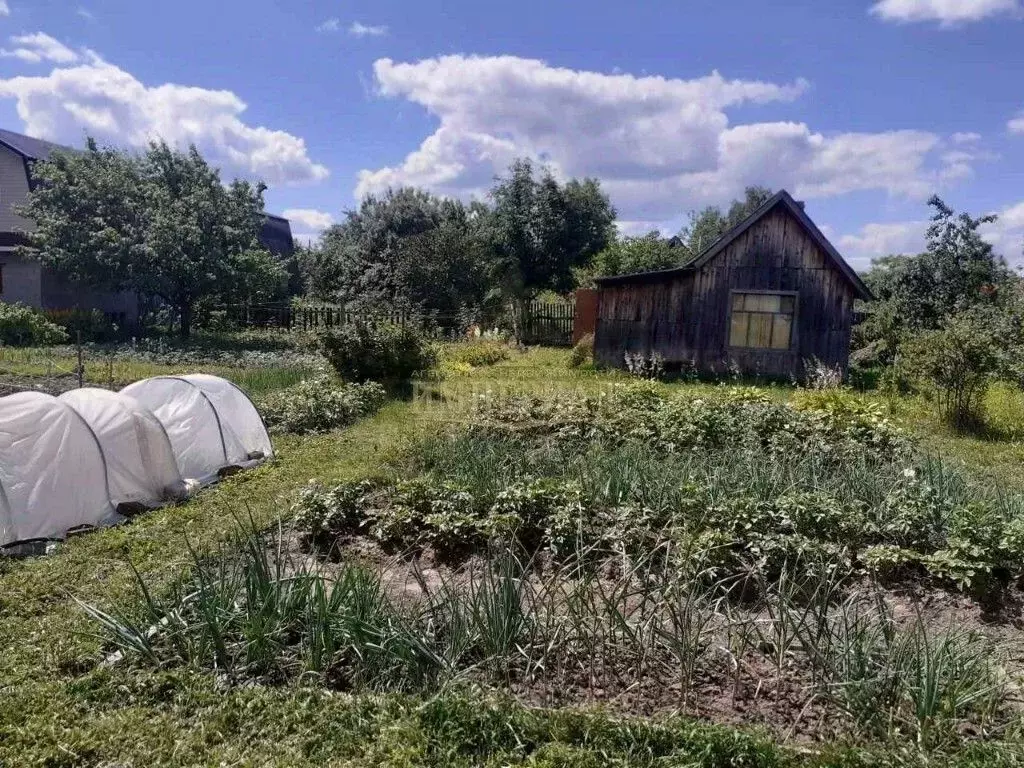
[260,374,387,434]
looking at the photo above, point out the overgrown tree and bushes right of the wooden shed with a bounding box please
[853,197,1024,432]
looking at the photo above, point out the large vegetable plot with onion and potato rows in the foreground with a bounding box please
[86,385,1024,751]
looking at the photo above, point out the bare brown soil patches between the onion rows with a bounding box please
[274,530,1024,742]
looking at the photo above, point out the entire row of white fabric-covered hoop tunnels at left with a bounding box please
[0,374,273,547]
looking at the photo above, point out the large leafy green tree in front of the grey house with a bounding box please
[22,140,287,336]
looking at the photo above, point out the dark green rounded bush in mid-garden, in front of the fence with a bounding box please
[319,322,437,384]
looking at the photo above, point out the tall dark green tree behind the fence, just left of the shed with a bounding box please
[490,160,615,303]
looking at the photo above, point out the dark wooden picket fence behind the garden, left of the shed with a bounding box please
[218,301,575,346]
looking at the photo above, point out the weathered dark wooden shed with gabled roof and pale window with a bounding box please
[594,189,871,378]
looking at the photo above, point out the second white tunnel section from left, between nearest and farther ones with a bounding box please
[58,387,186,508]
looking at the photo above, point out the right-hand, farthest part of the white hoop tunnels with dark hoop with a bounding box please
[121,374,273,482]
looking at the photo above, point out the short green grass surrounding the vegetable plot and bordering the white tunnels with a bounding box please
[6,350,1024,768]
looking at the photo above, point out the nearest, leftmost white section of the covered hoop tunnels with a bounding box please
[0,392,119,545]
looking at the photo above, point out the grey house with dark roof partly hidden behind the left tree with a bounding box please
[0,130,295,325]
